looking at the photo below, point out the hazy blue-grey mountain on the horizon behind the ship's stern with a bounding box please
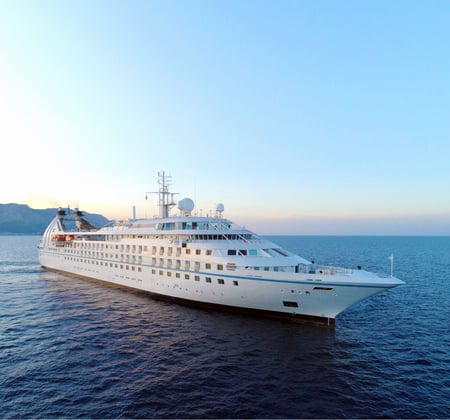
[0,203,108,235]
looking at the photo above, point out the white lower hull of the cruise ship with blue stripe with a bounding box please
[39,236,400,324]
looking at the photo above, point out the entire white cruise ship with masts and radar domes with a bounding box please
[38,172,404,326]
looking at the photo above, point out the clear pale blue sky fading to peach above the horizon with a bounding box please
[0,0,450,235]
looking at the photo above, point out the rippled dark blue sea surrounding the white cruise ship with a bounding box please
[0,236,450,418]
